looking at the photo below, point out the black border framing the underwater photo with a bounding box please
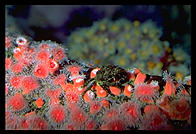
[0,0,194,134]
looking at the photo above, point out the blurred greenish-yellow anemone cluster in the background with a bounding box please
[67,18,190,80]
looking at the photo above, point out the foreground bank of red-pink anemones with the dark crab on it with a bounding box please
[5,33,191,130]
